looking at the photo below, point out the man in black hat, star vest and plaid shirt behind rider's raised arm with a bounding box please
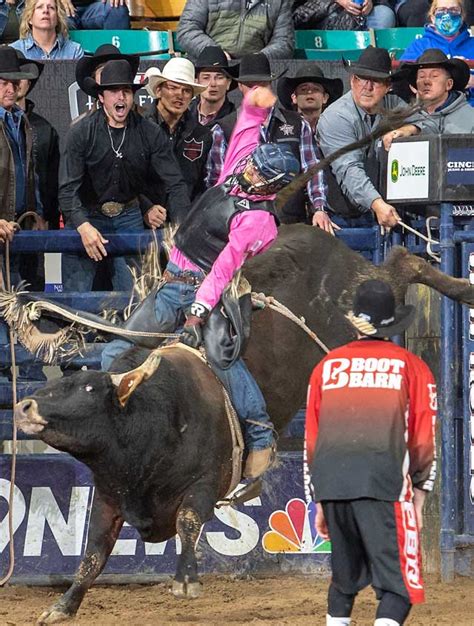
[213,53,334,233]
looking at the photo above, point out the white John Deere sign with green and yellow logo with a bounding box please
[387,141,430,200]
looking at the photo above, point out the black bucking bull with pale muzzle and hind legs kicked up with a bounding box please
[15,225,474,623]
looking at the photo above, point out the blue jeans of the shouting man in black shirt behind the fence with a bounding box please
[62,207,145,293]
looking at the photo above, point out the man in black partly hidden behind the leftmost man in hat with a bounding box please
[16,50,59,229]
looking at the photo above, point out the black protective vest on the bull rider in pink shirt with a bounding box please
[175,183,279,272]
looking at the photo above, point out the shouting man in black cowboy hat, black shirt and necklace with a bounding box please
[59,59,189,291]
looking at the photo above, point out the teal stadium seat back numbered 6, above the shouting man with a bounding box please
[69,30,170,59]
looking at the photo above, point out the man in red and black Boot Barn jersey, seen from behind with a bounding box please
[305,280,436,626]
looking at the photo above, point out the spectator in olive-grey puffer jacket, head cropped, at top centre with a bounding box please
[177,0,294,59]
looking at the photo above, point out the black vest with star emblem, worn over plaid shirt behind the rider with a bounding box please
[217,107,310,224]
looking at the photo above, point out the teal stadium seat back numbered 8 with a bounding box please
[295,30,374,50]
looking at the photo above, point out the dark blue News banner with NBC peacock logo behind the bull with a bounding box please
[0,452,330,583]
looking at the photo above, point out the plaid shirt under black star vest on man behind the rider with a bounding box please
[208,109,327,214]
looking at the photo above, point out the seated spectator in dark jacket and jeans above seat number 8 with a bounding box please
[293,0,395,30]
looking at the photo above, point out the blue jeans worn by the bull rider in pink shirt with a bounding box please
[102,263,273,450]
